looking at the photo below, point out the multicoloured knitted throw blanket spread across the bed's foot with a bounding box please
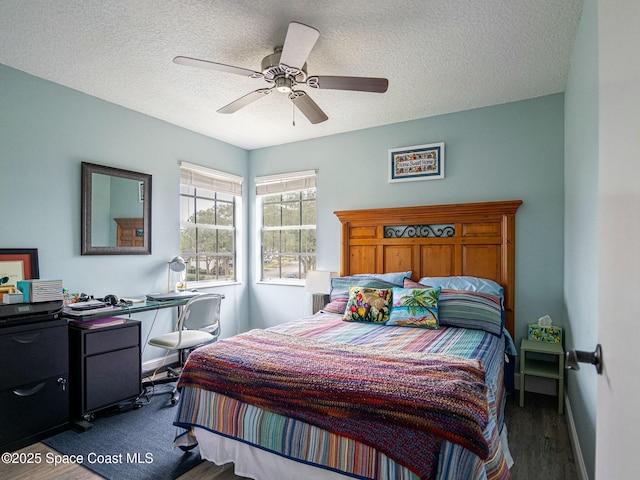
[179,330,489,478]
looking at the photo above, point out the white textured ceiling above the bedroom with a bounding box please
[0,0,582,149]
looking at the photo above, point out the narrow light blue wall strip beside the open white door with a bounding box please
[564,0,599,478]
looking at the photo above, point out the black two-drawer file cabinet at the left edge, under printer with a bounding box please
[0,302,69,452]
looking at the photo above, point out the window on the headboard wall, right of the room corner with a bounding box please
[256,170,316,283]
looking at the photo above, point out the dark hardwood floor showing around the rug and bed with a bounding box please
[0,392,578,480]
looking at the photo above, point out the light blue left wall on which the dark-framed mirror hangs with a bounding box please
[0,65,248,360]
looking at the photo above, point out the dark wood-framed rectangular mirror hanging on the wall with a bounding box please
[81,162,151,255]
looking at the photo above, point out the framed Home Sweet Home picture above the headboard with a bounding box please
[388,143,444,183]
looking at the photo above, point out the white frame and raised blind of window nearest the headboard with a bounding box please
[255,170,317,286]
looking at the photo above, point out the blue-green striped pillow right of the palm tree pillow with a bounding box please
[404,278,504,337]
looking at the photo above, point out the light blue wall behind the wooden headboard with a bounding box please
[249,94,565,338]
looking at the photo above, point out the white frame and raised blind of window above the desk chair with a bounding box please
[179,162,243,288]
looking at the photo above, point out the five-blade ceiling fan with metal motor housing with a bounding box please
[173,22,389,124]
